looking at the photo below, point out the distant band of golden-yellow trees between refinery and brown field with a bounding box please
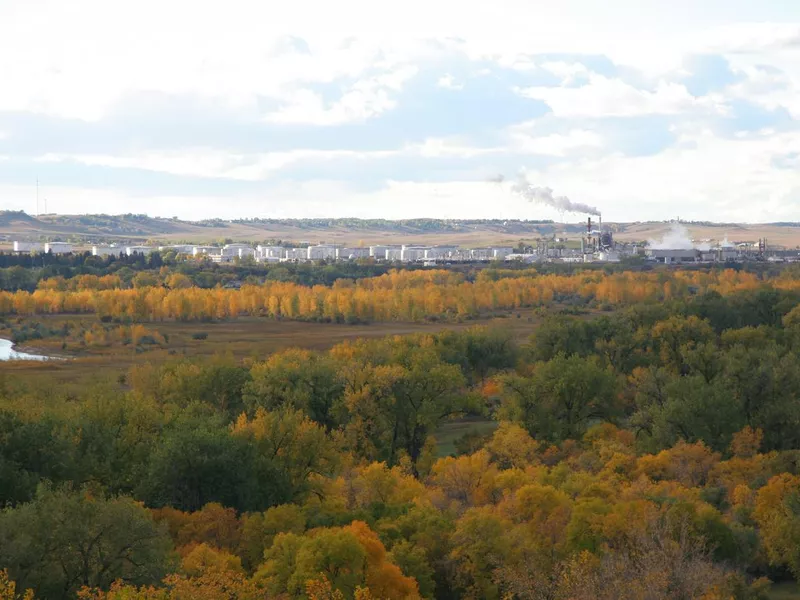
[0,269,800,322]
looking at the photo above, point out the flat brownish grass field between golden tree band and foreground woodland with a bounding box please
[0,309,552,382]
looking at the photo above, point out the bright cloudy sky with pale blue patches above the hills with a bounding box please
[0,0,800,222]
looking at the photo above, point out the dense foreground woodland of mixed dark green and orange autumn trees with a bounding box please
[6,288,800,600]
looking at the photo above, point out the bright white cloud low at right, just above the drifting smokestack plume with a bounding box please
[529,131,800,222]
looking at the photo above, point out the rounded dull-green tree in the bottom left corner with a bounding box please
[0,485,171,598]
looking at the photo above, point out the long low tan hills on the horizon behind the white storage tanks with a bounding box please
[0,211,800,248]
